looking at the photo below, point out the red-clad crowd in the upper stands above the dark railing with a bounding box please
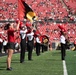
[0,0,76,20]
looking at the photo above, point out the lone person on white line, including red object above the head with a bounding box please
[58,25,67,60]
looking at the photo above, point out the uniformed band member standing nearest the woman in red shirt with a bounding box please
[20,26,27,63]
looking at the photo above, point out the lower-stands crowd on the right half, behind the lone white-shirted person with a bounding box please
[39,23,76,42]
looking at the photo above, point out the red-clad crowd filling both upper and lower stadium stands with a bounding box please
[0,0,76,52]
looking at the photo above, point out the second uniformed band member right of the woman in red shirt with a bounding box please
[27,28,34,60]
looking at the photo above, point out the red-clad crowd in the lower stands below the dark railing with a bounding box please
[0,23,76,53]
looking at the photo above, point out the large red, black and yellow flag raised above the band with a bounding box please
[18,0,36,21]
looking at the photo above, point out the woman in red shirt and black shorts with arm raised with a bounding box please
[4,22,20,71]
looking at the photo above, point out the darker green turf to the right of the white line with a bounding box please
[66,51,76,75]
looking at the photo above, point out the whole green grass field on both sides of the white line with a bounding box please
[0,50,76,75]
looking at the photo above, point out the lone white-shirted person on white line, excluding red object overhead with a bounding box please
[60,31,66,60]
